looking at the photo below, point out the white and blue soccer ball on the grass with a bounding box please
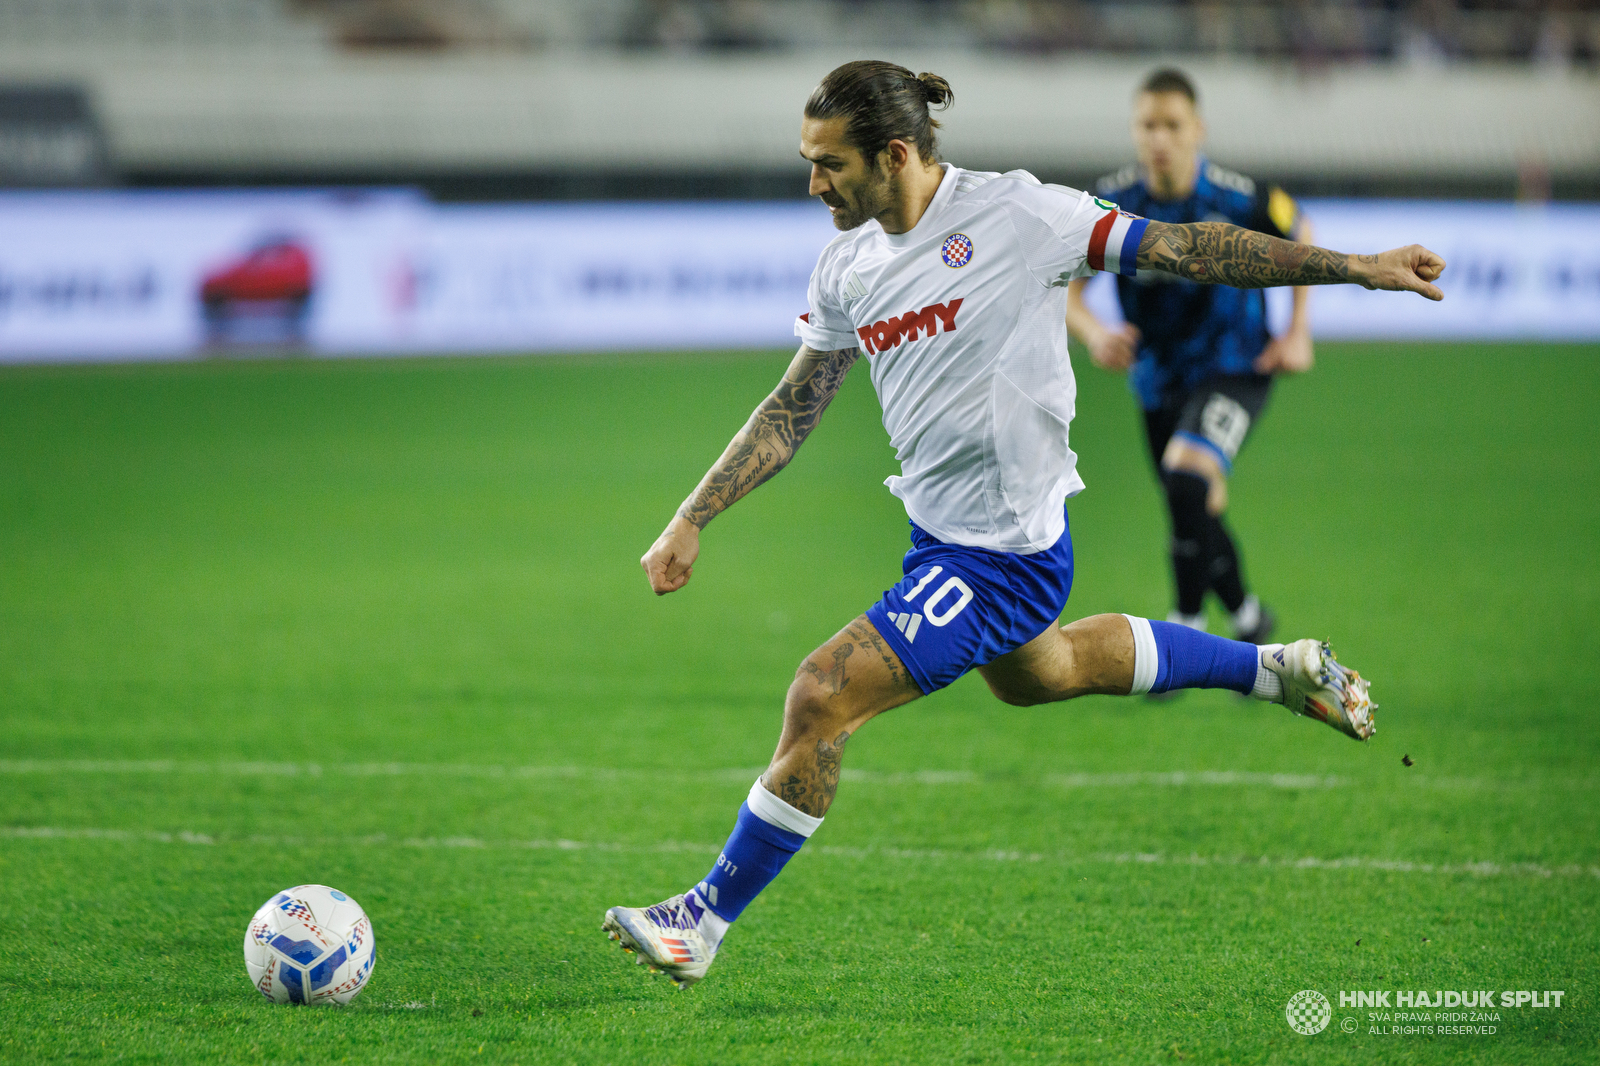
[245,885,378,1004]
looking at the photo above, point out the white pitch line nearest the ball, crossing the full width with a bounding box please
[0,826,1600,880]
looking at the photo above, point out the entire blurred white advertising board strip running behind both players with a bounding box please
[0,189,1600,362]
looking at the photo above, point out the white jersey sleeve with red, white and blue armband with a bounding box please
[1011,186,1149,285]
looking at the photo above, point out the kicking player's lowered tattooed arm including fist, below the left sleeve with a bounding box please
[638,344,861,595]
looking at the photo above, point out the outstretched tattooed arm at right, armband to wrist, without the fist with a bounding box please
[1138,222,1373,288]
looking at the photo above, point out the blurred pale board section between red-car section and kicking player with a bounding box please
[396,202,837,351]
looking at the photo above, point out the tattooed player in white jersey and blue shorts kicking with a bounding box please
[603,61,1445,988]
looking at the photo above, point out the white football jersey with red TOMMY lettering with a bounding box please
[795,163,1146,555]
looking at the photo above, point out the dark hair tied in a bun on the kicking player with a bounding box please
[805,59,955,166]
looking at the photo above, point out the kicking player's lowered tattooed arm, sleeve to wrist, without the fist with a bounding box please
[678,346,861,528]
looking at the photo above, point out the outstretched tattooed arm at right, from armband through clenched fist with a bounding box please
[1138,222,1445,299]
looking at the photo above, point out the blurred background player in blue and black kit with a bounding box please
[1067,69,1312,643]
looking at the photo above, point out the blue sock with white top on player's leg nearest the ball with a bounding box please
[693,778,822,943]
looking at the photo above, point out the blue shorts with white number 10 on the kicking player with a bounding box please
[867,505,1072,693]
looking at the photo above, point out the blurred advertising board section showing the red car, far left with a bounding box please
[0,190,427,362]
